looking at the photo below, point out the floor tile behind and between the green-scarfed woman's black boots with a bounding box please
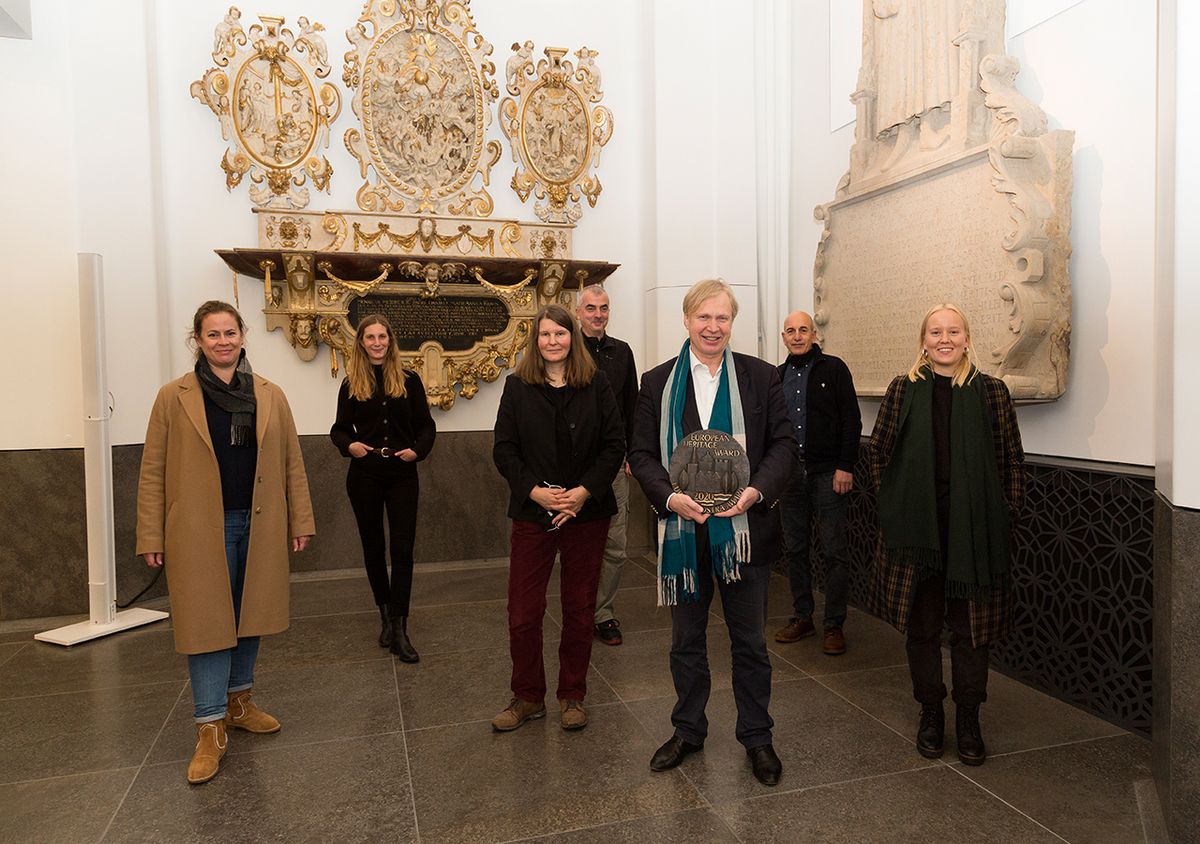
[820,652,1124,761]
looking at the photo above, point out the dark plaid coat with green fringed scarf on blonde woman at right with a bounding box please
[878,370,1009,599]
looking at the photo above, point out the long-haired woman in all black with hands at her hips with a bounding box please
[329,313,437,663]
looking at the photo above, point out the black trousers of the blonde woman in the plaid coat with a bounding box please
[906,577,988,705]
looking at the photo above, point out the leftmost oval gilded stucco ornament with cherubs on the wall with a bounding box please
[190,6,342,210]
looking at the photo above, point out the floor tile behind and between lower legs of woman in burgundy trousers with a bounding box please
[396,643,617,730]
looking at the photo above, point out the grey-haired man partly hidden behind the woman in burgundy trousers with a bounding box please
[575,285,637,645]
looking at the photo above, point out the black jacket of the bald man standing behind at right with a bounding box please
[776,346,863,474]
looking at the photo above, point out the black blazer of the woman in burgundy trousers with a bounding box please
[492,371,625,521]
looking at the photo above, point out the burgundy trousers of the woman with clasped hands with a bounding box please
[509,519,608,702]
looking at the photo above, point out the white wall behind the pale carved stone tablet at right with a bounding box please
[793,0,1157,465]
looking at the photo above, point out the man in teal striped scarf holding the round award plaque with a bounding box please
[629,280,797,785]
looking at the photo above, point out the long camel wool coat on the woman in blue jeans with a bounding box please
[137,372,316,653]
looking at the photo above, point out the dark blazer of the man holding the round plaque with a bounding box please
[629,352,797,565]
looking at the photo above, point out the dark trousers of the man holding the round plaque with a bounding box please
[671,525,775,748]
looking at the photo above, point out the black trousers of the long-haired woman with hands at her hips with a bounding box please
[346,455,420,616]
